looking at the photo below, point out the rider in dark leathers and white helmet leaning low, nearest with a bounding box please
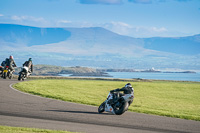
[110,83,134,106]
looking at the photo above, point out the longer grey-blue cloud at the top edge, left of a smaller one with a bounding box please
[79,0,122,5]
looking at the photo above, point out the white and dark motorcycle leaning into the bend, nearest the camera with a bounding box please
[98,92,134,115]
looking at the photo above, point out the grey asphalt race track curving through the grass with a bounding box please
[0,79,200,133]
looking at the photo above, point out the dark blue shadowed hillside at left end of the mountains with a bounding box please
[0,24,70,47]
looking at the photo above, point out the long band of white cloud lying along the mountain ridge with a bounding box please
[0,14,191,38]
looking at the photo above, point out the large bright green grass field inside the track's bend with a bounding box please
[14,79,200,121]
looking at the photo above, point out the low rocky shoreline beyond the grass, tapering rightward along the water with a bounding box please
[15,65,196,78]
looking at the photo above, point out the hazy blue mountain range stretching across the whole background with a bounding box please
[0,24,200,70]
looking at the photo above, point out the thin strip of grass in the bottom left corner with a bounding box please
[0,126,76,133]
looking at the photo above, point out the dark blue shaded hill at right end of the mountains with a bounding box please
[144,34,200,55]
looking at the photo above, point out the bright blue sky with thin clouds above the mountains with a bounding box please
[0,0,200,37]
